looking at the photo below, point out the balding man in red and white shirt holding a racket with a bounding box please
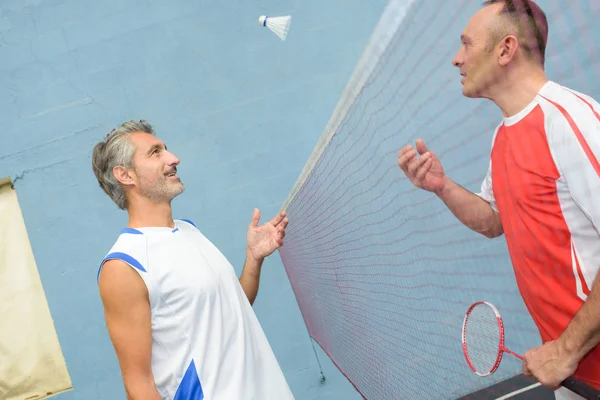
[398,0,600,399]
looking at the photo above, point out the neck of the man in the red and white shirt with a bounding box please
[491,66,548,117]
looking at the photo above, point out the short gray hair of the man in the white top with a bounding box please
[92,120,154,210]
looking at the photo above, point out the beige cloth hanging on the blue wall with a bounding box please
[0,179,72,400]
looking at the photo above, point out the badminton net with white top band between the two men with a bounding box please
[280,0,600,399]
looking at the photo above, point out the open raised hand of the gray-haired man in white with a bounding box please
[246,208,288,260]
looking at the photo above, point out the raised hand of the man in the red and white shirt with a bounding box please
[398,139,445,192]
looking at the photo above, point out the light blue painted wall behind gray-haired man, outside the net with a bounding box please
[0,0,385,400]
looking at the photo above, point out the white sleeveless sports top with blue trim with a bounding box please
[98,220,293,400]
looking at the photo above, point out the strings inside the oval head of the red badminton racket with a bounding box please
[465,304,502,374]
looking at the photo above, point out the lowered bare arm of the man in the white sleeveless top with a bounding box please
[98,260,161,400]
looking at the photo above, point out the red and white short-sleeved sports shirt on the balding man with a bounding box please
[478,81,600,388]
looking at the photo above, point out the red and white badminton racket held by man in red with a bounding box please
[462,301,600,400]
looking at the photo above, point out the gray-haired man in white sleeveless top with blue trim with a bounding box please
[92,121,293,400]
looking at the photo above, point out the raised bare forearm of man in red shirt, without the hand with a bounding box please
[436,176,504,238]
